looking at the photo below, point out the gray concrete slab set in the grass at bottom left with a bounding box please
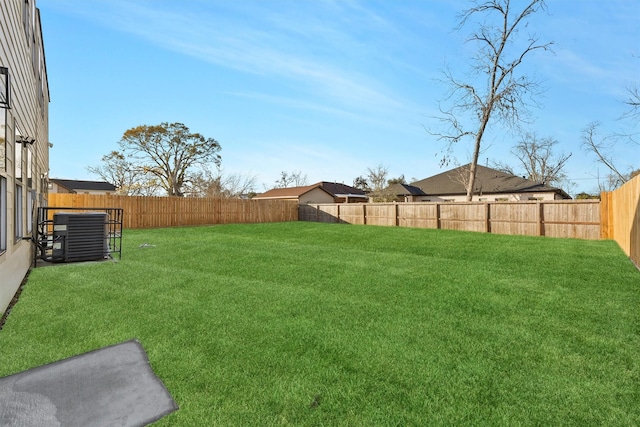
[0,340,178,427]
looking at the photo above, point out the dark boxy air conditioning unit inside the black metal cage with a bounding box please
[52,212,109,262]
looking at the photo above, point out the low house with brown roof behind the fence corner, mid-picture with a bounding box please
[253,181,367,204]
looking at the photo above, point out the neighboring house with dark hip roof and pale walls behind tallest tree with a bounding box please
[411,164,571,202]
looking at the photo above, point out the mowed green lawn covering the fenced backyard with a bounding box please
[0,222,640,426]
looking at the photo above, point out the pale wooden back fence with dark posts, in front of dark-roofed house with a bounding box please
[298,200,601,240]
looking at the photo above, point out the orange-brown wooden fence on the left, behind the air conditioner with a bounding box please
[48,193,298,228]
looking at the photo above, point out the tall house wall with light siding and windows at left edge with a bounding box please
[0,0,49,315]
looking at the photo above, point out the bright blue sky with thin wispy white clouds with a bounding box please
[37,0,640,193]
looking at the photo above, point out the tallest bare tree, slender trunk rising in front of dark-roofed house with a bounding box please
[431,0,552,201]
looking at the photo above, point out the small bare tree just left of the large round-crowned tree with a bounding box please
[87,151,161,196]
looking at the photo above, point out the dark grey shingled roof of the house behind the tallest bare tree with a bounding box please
[411,164,571,199]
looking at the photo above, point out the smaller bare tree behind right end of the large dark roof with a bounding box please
[499,133,571,185]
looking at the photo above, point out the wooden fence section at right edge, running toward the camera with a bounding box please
[601,175,640,268]
